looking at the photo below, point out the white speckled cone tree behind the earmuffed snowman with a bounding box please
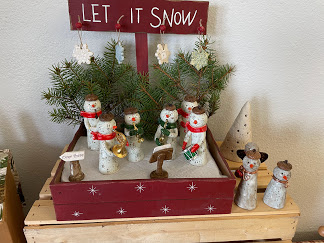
[220,101,252,162]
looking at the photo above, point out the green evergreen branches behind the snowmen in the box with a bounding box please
[42,37,234,139]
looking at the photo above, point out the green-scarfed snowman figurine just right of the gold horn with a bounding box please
[123,107,144,162]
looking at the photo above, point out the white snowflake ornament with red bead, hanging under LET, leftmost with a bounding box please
[72,16,93,64]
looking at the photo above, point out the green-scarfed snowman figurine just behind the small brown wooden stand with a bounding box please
[154,104,178,159]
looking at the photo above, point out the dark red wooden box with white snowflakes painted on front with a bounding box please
[50,126,236,221]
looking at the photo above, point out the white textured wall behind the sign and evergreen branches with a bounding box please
[0,0,324,240]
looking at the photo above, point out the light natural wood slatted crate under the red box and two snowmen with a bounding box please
[24,146,300,243]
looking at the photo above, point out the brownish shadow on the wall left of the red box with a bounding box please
[0,110,63,214]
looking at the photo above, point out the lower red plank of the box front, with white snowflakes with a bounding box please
[55,198,233,221]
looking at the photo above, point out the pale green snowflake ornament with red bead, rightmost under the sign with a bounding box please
[190,19,209,70]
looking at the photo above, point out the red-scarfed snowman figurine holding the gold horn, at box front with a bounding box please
[92,113,119,175]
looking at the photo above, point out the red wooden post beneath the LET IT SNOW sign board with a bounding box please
[135,33,148,74]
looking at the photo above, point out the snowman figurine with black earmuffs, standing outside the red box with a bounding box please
[234,142,268,210]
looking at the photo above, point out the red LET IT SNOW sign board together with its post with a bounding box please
[69,0,209,74]
